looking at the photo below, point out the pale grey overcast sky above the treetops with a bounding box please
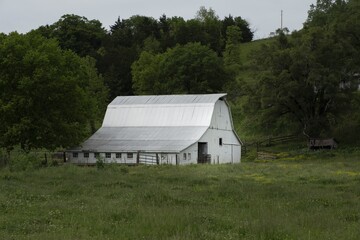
[0,0,316,39]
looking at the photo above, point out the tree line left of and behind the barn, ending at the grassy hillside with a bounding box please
[0,7,253,151]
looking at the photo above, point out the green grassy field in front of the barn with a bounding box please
[0,149,360,240]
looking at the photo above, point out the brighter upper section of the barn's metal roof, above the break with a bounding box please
[102,94,226,127]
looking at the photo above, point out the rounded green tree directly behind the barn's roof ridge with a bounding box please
[132,43,226,94]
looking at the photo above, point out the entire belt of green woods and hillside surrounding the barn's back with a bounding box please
[0,0,360,151]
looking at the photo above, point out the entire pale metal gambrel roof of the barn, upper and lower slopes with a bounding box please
[81,94,226,153]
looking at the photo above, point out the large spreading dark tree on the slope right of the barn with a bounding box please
[251,24,354,137]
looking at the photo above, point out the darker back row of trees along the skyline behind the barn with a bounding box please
[34,7,253,99]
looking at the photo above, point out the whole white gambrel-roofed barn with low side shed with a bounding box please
[68,94,242,165]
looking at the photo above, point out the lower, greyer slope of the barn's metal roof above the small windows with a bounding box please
[81,127,207,152]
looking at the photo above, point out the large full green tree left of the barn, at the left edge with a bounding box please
[0,32,106,150]
